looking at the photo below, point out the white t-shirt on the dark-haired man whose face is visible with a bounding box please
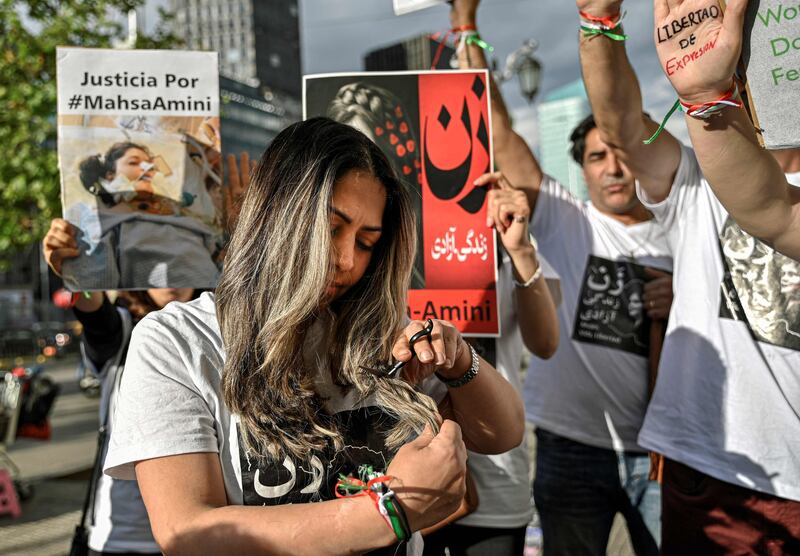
[525,176,672,451]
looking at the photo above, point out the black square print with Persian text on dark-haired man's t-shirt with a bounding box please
[572,255,650,356]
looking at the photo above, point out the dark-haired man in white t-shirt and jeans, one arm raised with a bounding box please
[451,0,672,555]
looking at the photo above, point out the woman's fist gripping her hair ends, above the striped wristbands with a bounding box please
[386,420,467,531]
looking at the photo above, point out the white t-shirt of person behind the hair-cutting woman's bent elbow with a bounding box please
[458,256,546,528]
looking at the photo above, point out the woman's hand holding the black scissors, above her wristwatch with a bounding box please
[392,320,472,384]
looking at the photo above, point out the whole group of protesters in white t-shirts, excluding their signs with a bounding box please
[44,0,800,556]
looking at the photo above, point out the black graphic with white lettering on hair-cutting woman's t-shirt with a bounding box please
[239,407,405,555]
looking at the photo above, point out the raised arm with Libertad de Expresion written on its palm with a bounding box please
[655,0,800,259]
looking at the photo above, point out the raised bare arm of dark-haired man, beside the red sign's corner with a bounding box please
[450,0,542,210]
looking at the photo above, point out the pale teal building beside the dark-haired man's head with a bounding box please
[538,79,591,200]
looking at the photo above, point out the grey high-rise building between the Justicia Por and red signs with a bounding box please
[170,0,302,158]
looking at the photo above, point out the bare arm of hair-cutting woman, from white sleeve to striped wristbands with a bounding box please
[136,453,404,556]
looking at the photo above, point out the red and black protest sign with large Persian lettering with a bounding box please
[303,70,500,336]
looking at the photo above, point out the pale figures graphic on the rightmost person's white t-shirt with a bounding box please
[719,216,800,350]
